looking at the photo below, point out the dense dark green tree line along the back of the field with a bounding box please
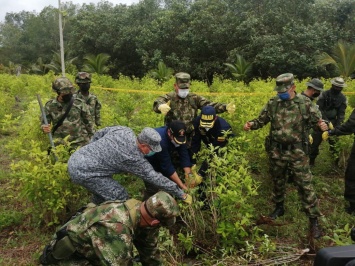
[0,0,355,81]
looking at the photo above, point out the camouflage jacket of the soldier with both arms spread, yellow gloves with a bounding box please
[153,91,226,133]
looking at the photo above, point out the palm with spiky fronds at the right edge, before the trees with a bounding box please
[316,41,355,78]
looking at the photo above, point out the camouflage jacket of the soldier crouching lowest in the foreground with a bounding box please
[52,199,161,266]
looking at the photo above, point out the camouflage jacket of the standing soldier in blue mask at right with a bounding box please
[249,94,321,144]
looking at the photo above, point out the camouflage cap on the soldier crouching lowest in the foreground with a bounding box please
[146,191,180,226]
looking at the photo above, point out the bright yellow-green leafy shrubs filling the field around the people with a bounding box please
[0,72,355,265]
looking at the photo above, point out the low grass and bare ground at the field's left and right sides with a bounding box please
[0,132,354,265]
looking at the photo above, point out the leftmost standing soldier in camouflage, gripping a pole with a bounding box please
[41,77,94,148]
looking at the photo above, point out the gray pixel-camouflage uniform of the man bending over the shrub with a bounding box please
[68,126,184,200]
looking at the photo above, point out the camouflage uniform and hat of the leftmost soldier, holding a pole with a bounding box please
[42,78,94,147]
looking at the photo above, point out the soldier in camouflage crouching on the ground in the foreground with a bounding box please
[40,191,179,266]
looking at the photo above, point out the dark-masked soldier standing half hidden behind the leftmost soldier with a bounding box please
[74,72,101,127]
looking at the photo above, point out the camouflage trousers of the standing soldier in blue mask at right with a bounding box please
[269,147,322,218]
